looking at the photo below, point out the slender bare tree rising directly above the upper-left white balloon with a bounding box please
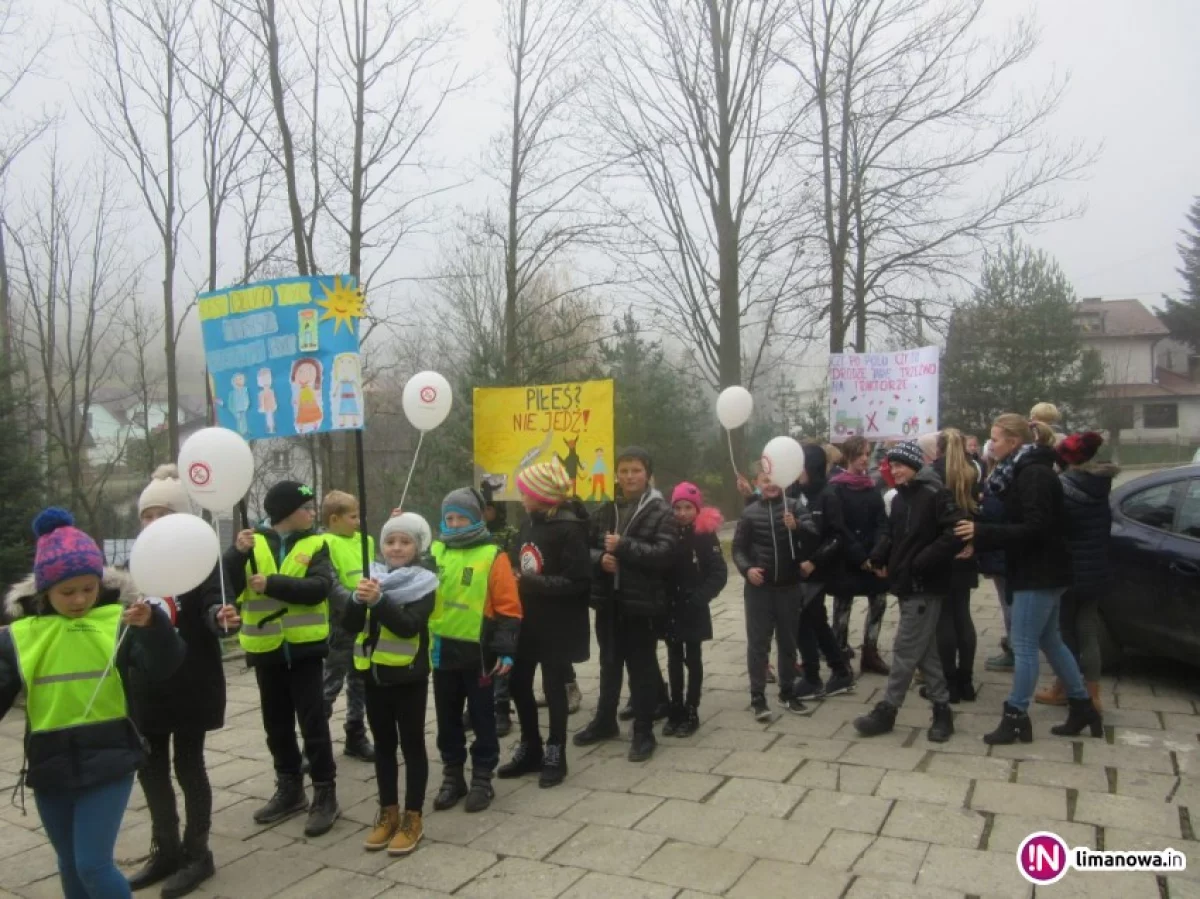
[80,0,196,457]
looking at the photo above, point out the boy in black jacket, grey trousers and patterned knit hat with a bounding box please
[854,442,966,743]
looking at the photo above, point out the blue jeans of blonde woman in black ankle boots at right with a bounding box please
[1008,588,1087,712]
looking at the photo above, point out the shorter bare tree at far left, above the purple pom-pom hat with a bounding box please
[6,146,134,525]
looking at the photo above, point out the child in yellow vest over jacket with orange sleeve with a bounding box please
[430,487,521,811]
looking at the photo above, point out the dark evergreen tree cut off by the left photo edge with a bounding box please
[0,360,44,585]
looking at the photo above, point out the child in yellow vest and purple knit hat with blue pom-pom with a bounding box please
[0,509,184,899]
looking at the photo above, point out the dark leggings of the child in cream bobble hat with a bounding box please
[138,731,212,852]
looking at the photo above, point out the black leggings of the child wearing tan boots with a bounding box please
[366,681,430,811]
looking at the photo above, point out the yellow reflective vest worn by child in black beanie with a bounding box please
[238,534,329,654]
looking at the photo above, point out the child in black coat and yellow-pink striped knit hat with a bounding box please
[497,460,592,786]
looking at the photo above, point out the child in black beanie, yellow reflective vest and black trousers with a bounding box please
[224,481,341,837]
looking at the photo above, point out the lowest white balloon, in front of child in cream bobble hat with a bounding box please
[130,514,221,597]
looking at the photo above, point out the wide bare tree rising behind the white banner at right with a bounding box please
[785,0,1090,353]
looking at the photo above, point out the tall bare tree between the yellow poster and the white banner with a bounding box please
[596,0,802,386]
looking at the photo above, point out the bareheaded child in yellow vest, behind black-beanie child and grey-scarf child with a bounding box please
[320,490,374,762]
